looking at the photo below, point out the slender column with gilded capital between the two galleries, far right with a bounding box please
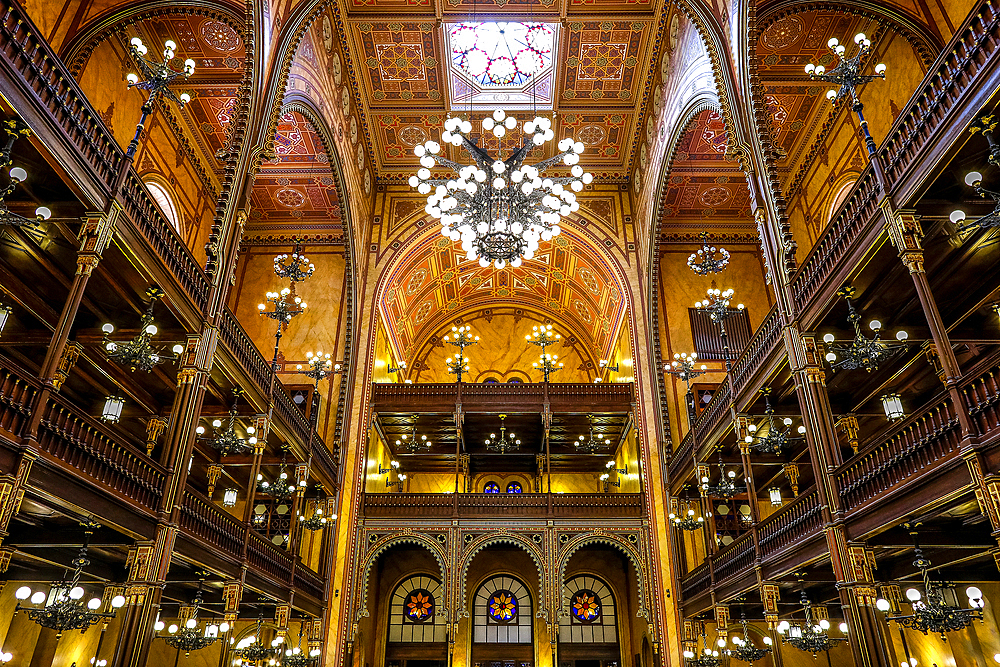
[880,209,972,438]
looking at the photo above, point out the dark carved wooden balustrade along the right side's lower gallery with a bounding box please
[681,363,1000,614]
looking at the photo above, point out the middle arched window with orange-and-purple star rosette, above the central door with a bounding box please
[472,575,535,644]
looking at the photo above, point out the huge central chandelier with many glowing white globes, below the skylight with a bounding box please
[409,109,594,269]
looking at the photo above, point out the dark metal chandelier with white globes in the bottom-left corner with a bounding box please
[14,524,125,639]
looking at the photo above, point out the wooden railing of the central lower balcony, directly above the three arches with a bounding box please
[363,493,643,519]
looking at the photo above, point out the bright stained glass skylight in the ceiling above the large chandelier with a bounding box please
[445,22,558,110]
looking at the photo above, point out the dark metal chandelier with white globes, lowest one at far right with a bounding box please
[875,524,986,640]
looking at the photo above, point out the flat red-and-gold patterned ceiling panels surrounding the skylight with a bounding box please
[343,0,659,182]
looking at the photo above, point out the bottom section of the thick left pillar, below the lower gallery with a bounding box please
[111,524,177,667]
